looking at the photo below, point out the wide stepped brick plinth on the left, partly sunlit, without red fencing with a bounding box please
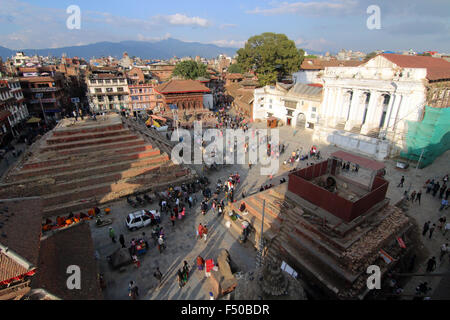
[0,116,190,217]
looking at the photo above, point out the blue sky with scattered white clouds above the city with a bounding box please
[0,0,450,53]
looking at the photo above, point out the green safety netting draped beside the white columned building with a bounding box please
[400,106,450,168]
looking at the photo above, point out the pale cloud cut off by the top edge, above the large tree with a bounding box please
[246,0,358,16]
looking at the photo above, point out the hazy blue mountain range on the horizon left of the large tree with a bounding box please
[0,38,238,59]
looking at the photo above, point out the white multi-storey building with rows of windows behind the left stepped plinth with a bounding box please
[87,73,130,112]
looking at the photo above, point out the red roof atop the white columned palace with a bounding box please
[381,53,450,80]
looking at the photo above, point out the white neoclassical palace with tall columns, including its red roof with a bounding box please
[314,54,450,159]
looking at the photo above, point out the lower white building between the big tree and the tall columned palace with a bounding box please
[253,83,322,129]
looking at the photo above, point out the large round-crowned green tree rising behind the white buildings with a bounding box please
[237,32,301,86]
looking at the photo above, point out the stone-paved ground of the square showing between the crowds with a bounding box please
[91,123,450,300]
